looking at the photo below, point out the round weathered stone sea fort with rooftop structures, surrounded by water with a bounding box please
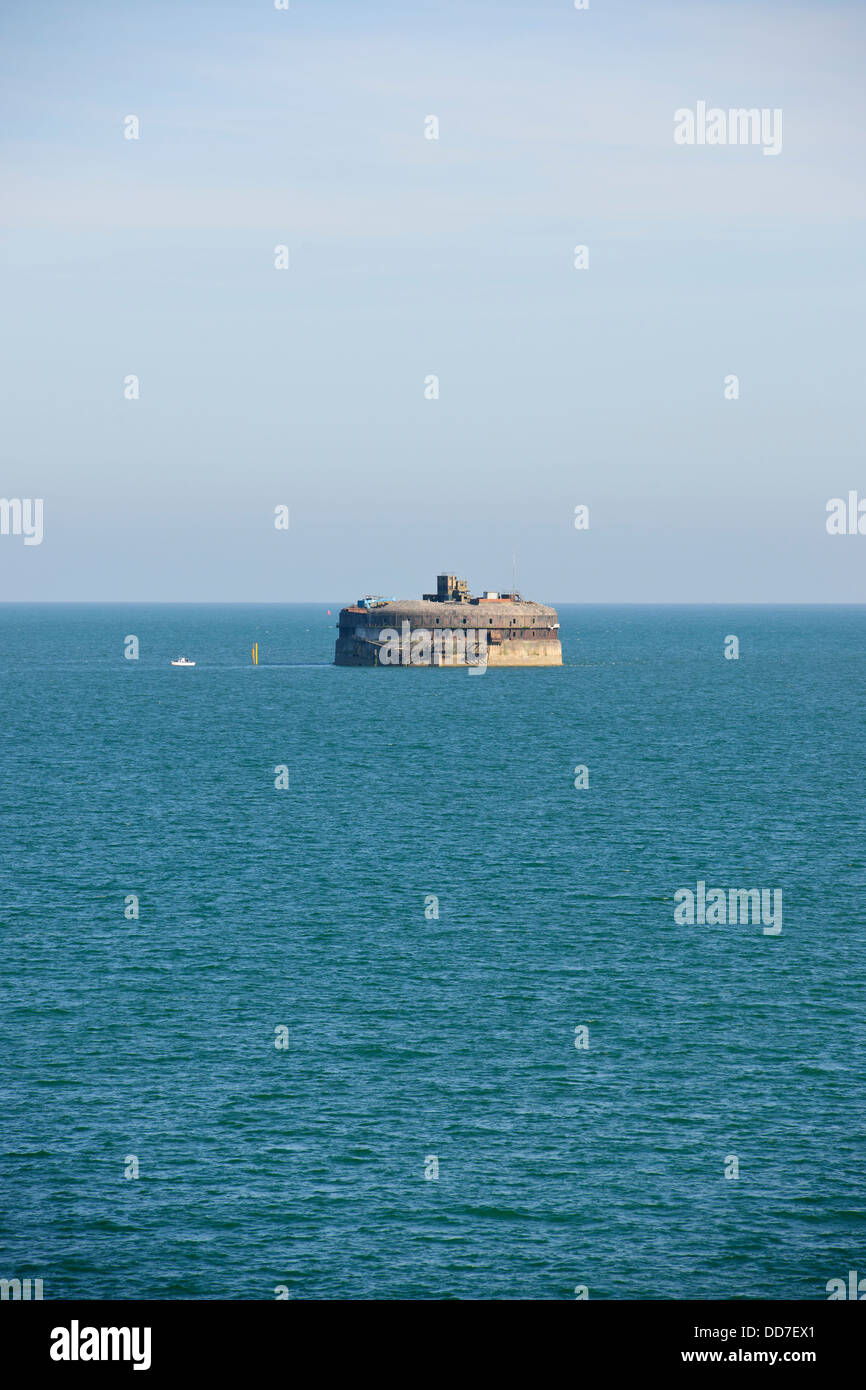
[334,574,563,666]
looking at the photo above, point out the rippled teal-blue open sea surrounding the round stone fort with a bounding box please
[0,603,866,1298]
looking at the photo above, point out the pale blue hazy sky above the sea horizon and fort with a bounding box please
[0,0,866,602]
